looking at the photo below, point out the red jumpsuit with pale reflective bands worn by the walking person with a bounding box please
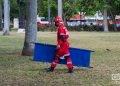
[51,24,73,69]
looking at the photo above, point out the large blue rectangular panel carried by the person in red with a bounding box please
[33,43,92,67]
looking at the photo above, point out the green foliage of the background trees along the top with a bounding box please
[0,0,120,31]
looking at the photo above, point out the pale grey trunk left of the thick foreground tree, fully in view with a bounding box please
[3,0,10,35]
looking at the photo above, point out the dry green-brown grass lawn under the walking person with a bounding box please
[0,32,120,86]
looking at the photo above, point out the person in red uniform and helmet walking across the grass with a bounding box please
[47,16,73,73]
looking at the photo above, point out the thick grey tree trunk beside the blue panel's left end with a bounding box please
[22,0,37,56]
